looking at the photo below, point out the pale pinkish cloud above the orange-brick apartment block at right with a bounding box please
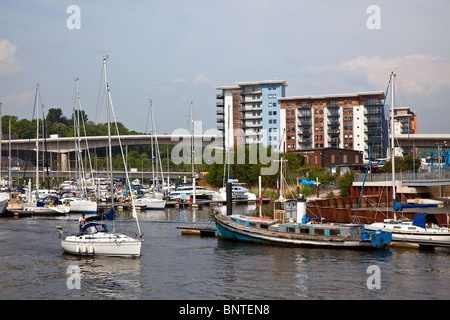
[301,54,450,94]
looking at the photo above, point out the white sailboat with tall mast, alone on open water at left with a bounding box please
[57,57,143,257]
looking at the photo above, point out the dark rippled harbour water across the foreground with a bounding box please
[0,207,450,300]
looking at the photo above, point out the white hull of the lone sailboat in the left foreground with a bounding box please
[61,233,142,257]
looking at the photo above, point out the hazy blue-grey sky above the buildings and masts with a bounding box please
[0,0,450,134]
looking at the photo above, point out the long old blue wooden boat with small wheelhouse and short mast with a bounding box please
[214,158,392,250]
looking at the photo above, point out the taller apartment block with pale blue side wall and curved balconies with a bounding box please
[216,80,287,150]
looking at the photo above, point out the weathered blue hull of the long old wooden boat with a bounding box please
[215,214,391,249]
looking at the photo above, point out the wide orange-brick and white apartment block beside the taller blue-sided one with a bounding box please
[278,91,389,160]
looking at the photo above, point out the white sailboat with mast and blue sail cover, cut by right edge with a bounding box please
[364,72,450,247]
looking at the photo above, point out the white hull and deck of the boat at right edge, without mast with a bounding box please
[365,213,450,247]
